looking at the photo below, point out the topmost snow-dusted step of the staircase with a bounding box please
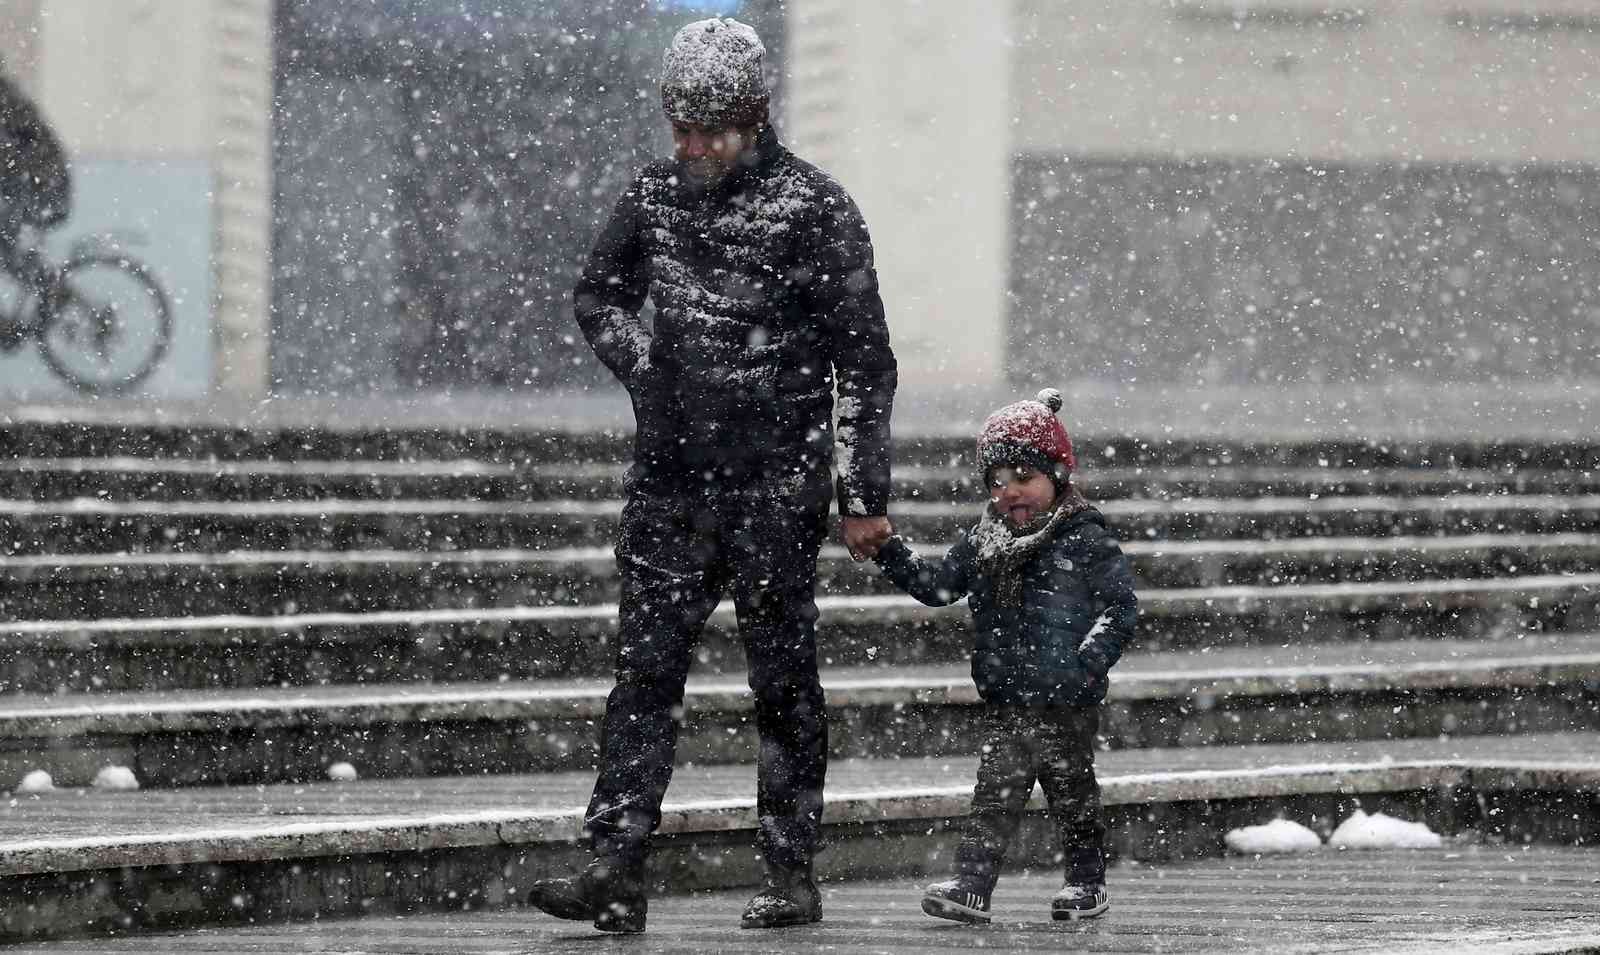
[0,412,1600,472]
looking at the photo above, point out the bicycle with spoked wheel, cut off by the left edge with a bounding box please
[0,223,173,395]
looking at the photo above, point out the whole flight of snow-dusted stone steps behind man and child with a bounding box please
[0,424,1600,939]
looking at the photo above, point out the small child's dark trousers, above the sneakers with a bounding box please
[955,705,1106,893]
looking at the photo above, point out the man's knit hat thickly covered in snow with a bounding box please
[661,18,766,130]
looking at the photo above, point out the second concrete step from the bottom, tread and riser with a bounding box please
[0,633,1600,787]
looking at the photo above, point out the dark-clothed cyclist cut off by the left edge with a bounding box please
[0,72,72,349]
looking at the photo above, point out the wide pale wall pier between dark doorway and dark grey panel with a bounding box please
[782,0,1013,390]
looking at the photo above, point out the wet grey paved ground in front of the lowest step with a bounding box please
[10,838,1600,955]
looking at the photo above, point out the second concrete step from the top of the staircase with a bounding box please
[15,456,1600,501]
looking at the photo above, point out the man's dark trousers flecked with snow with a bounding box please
[586,474,830,867]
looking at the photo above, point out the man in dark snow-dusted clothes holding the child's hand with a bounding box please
[530,19,896,933]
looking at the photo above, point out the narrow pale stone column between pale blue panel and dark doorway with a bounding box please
[211,0,272,400]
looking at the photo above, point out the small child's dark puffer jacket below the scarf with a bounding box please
[877,507,1139,705]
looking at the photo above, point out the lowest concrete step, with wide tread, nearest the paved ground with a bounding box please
[0,733,1600,939]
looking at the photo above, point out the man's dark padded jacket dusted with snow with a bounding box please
[573,128,896,515]
